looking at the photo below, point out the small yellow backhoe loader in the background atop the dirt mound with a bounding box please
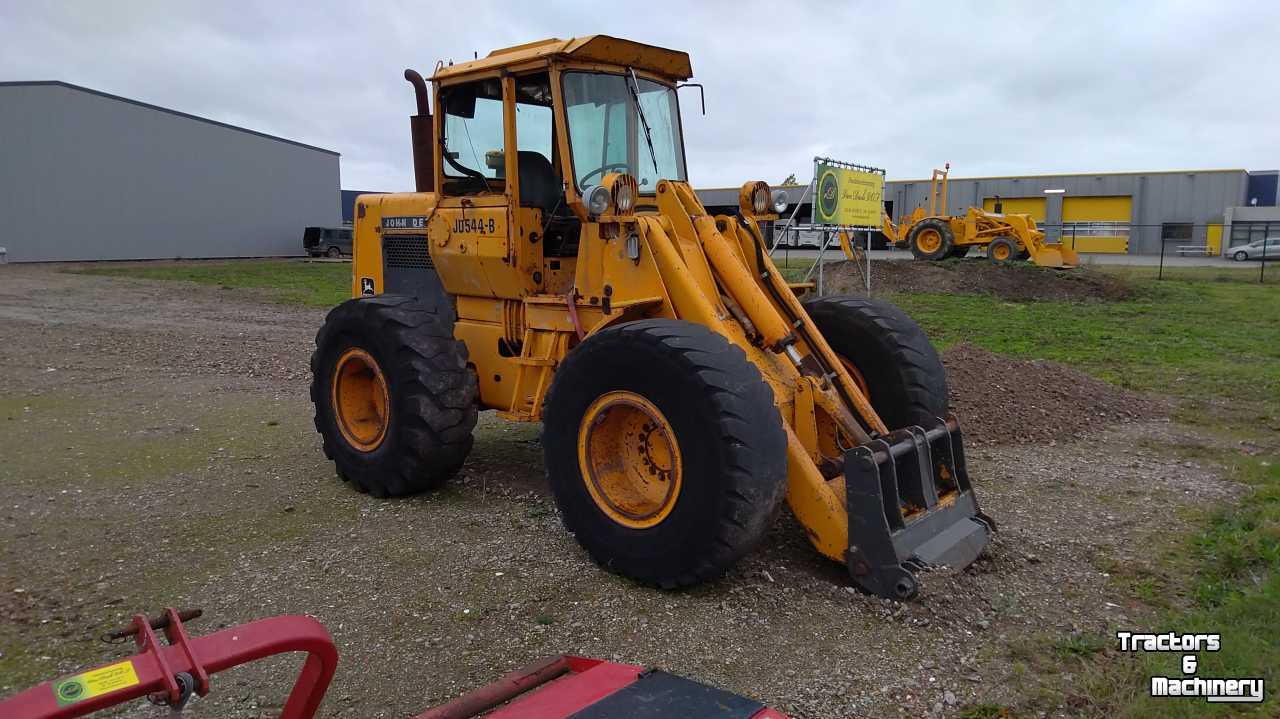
[881,164,1080,269]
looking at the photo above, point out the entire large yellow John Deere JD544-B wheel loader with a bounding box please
[312,36,993,597]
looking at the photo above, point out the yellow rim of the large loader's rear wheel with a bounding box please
[329,347,390,452]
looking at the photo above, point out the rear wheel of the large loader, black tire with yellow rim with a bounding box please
[311,296,479,496]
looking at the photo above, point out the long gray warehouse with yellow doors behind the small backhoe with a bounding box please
[699,165,1280,256]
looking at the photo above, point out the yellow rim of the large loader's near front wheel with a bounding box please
[577,391,684,530]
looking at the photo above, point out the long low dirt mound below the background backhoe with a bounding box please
[824,258,1133,302]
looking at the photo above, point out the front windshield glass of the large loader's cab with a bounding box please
[564,72,687,192]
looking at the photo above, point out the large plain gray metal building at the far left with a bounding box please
[0,82,342,262]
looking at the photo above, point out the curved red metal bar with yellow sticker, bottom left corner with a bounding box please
[0,609,338,719]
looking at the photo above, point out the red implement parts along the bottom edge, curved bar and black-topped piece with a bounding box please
[0,609,787,719]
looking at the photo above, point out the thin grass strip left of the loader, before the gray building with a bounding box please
[67,260,351,307]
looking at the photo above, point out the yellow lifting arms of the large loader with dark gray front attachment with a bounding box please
[637,180,992,597]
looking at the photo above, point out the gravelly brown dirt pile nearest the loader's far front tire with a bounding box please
[942,344,1169,444]
